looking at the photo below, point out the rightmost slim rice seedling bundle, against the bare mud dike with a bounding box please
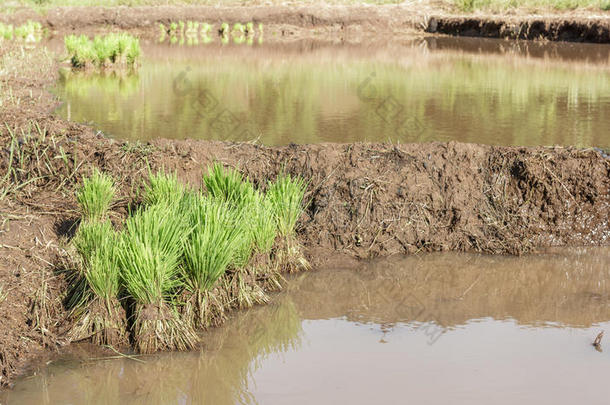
[267,173,309,271]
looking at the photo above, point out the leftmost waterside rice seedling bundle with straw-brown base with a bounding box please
[69,221,128,346]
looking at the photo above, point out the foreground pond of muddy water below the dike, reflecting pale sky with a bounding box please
[2,248,610,404]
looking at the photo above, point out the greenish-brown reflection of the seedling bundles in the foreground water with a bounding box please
[9,295,302,405]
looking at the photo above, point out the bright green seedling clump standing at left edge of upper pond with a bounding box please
[64,33,141,68]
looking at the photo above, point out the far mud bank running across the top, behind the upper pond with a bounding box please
[0,4,610,43]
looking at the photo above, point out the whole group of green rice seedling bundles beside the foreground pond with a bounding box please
[68,164,306,353]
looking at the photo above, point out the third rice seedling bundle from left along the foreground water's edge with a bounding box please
[184,196,243,327]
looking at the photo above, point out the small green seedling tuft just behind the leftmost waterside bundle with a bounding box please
[76,169,116,221]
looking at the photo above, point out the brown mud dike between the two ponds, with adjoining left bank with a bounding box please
[0,13,610,386]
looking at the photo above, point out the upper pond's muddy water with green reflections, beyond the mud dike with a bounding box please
[56,38,610,147]
